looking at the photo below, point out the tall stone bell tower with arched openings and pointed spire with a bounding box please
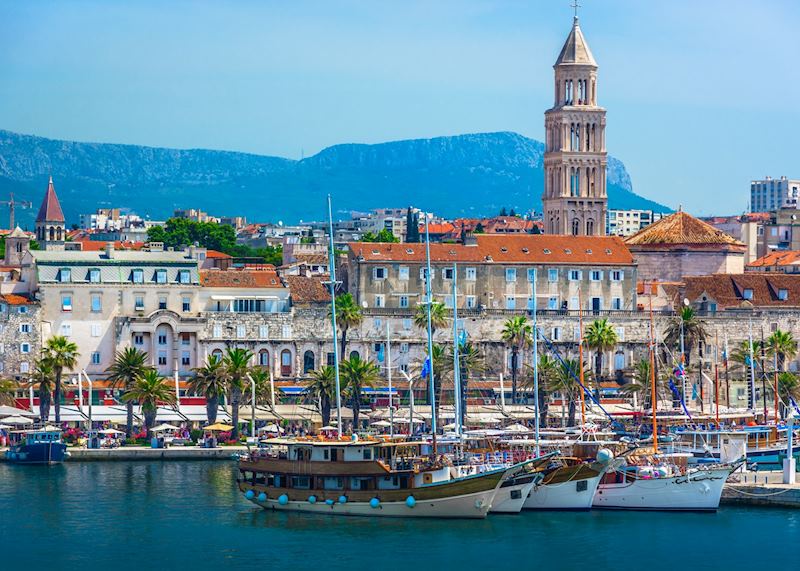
[542,15,608,236]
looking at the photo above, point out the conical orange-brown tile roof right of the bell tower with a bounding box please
[625,210,745,250]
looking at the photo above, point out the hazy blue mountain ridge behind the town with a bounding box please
[0,130,669,227]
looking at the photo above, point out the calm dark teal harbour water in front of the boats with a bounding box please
[0,462,800,571]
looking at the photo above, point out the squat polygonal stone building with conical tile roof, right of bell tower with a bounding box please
[625,211,745,281]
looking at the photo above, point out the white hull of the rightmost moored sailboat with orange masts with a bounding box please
[593,467,730,511]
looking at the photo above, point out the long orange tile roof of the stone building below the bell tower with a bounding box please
[348,234,633,265]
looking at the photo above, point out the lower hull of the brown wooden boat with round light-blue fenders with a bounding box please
[245,489,495,519]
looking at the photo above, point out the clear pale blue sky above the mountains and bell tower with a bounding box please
[0,0,800,214]
